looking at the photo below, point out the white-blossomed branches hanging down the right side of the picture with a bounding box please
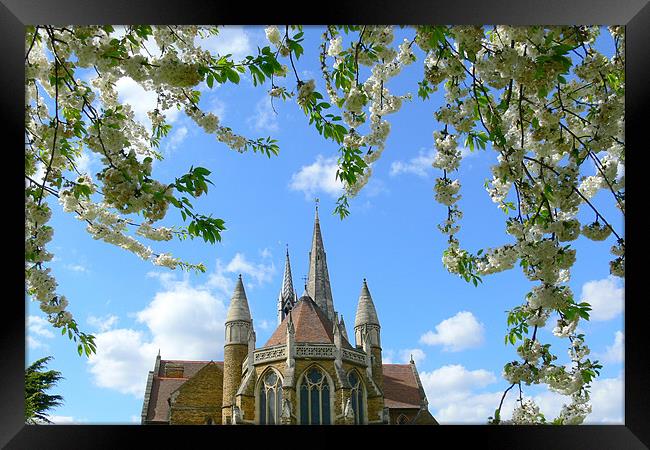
[415,26,625,423]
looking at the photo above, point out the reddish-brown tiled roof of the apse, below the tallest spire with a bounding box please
[263,295,352,349]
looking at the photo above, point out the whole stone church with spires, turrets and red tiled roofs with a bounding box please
[141,207,437,425]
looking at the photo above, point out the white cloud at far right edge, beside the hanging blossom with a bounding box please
[580,275,625,320]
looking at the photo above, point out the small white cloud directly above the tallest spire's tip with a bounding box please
[289,155,343,200]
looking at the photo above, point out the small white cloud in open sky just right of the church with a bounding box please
[420,311,485,352]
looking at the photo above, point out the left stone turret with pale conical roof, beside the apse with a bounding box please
[221,274,253,424]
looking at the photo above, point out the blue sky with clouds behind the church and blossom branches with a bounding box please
[26,27,624,424]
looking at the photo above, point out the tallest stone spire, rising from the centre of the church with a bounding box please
[307,204,334,321]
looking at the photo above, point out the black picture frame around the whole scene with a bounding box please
[0,0,650,450]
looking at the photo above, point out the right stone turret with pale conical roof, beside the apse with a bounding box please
[354,278,384,389]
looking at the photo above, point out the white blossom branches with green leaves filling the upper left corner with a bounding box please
[25,26,266,336]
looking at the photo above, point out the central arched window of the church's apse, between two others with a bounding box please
[299,367,332,425]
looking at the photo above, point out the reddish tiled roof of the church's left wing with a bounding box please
[146,359,223,422]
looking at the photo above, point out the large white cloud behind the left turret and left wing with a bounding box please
[88,253,275,398]
